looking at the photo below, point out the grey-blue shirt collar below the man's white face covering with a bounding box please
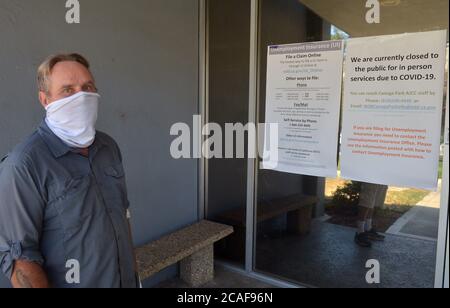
[38,120,106,158]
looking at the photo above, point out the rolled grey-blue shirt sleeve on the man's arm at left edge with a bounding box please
[0,160,45,279]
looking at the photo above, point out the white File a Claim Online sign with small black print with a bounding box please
[262,41,343,177]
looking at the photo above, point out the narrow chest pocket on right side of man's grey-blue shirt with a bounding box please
[101,163,129,213]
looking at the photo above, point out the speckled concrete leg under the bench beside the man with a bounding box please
[180,245,214,288]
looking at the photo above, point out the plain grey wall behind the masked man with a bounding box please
[0,0,199,287]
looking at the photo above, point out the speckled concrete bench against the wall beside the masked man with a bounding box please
[136,220,233,287]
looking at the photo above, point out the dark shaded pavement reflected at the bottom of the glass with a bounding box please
[256,221,436,288]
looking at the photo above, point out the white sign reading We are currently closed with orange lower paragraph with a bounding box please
[341,31,447,190]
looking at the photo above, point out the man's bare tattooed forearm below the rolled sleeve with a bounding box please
[11,260,50,289]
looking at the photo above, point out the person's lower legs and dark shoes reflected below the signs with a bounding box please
[355,183,388,248]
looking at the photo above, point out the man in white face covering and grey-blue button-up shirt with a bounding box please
[0,54,138,288]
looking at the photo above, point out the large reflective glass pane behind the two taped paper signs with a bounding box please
[254,0,448,288]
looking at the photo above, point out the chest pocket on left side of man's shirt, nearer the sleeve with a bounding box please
[49,175,96,231]
